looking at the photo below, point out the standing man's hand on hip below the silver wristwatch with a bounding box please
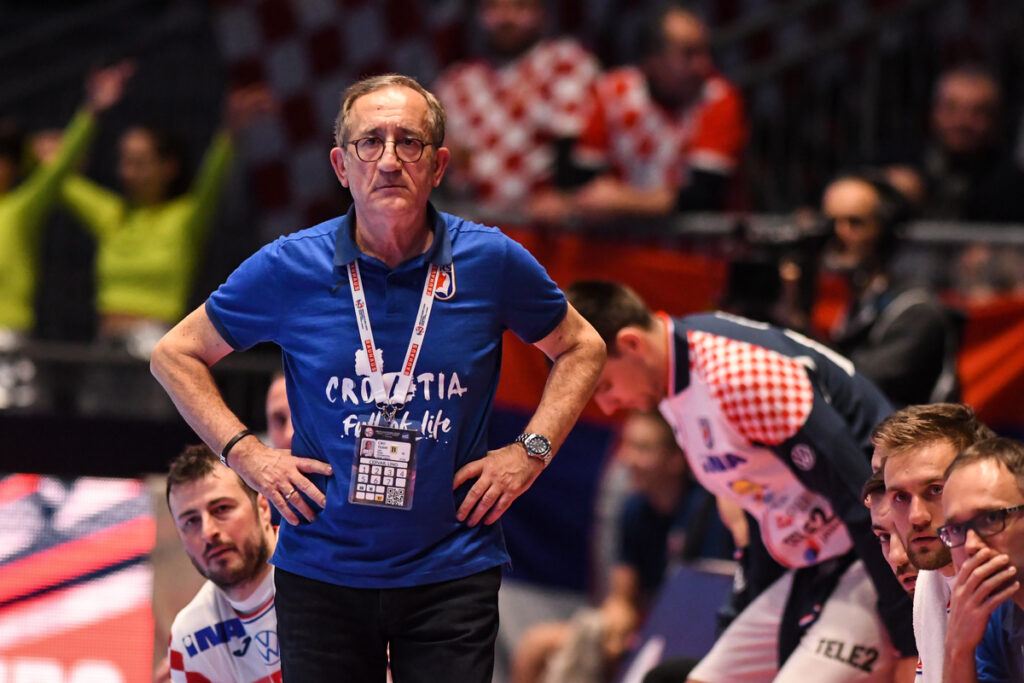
[453,443,544,526]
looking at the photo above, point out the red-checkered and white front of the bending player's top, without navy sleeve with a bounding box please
[658,319,852,567]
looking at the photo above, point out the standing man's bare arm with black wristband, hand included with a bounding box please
[150,306,332,524]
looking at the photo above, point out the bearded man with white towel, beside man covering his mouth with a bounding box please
[871,403,994,683]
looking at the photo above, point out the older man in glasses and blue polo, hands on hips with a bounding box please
[152,75,604,683]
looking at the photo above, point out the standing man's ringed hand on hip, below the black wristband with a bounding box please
[227,439,334,524]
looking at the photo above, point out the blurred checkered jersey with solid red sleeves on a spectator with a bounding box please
[575,67,748,189]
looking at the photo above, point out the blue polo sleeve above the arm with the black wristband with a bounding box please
[206,240,285,351]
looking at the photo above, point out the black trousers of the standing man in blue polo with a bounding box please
[274,567,502,683]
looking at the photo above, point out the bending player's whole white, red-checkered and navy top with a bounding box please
[659,313,890,567]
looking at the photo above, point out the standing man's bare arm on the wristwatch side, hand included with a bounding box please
[455,305,605,526]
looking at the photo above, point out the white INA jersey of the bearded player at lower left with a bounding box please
[168,568,281,683]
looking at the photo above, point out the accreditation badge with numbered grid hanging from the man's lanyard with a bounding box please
[348,424,418,510]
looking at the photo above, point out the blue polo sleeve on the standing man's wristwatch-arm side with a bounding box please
[501,238,568,344]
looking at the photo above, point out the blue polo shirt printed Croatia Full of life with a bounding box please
[206,202,566,588]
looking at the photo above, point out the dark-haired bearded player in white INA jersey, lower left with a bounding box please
[167,445,281,683]
